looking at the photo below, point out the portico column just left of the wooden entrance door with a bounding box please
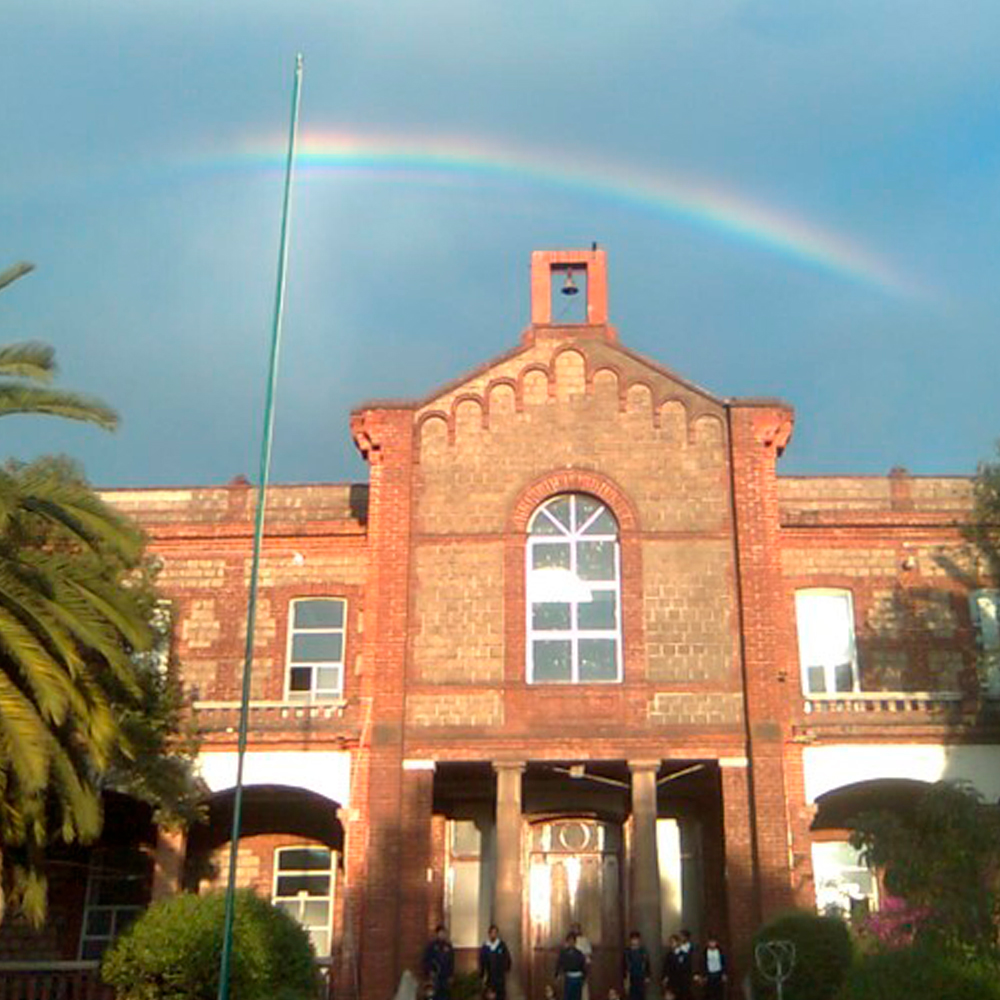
[493,761,524,1000]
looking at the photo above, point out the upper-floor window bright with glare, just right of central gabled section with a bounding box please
[795,589,858,694]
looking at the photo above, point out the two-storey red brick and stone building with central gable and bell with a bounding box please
[0,250,1000,1000]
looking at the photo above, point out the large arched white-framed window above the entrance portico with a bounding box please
[527,493,622,684]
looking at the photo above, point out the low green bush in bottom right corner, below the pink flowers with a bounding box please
[837,947,1000,1000]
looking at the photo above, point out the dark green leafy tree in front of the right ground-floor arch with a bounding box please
[851,782,1000,955]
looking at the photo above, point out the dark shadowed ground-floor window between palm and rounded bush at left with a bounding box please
[80,848,153,959]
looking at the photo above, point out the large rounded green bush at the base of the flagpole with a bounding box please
[101,890,318,1000]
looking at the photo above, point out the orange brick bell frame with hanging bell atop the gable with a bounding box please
[531,244,608,326]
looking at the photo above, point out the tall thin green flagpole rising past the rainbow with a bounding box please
[218,54,302,1000]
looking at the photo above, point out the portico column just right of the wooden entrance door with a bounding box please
[628,760,663,1000]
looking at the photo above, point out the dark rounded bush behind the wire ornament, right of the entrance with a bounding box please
[753,912,854,1000]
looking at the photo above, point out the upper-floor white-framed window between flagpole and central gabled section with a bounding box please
[288,597,347,701]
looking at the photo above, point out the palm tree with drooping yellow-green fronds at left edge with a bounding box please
[0,264,153,921]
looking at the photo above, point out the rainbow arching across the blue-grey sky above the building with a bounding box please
[232,131,919,296]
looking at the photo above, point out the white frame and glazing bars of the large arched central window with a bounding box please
[525,493,623,684]
